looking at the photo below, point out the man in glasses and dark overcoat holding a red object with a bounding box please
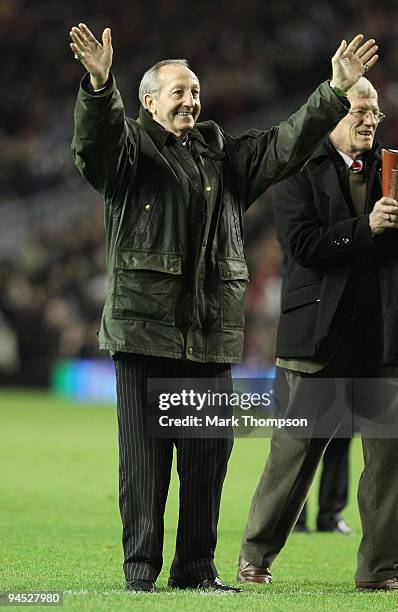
[238,78,398,591]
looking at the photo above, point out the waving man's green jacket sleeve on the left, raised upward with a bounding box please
[72,74,136,202]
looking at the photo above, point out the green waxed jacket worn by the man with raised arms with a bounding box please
[72,75,347,363]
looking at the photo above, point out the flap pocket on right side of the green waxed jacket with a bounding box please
[218,258,249,328]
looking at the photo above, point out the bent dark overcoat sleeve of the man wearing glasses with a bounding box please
[273,169,377,269]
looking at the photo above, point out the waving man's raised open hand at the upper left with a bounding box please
[69,23,113,89]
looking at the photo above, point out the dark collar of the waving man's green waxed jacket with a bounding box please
[137,105,224,159]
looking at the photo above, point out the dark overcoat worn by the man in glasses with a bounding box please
[274,142,398,363]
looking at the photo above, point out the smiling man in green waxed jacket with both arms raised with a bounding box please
[70,24,377,592]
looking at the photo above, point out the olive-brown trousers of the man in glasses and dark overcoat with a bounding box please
[241,313,398,581]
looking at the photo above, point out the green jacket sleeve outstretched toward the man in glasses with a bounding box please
[230,81,349,207]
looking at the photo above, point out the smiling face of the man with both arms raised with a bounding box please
[145,64,200,138]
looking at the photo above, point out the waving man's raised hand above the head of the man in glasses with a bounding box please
[331,34,379,92]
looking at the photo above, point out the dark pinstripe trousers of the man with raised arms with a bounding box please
[115,354,233,582]
